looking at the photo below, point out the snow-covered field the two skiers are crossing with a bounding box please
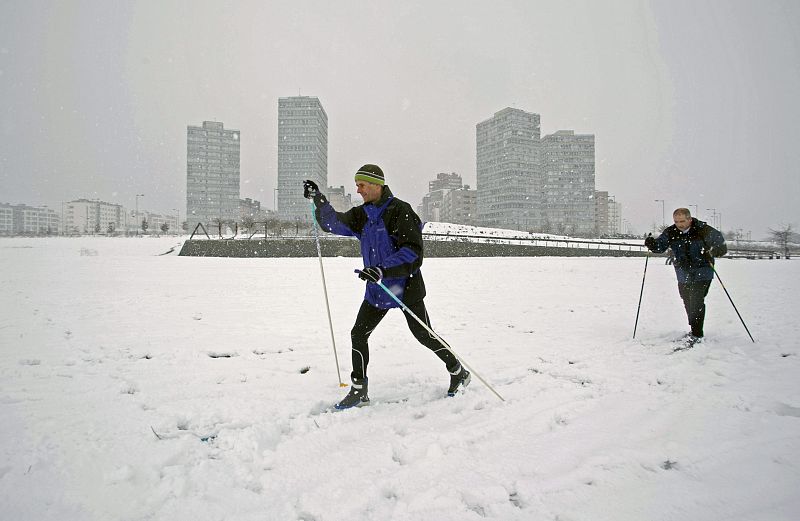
[0,238,800,521]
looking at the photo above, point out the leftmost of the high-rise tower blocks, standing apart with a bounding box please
[186,121,240,228]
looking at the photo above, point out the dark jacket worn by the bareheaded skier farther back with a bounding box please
[652,217,728,284]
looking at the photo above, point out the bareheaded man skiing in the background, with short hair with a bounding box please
[644,208,728,346]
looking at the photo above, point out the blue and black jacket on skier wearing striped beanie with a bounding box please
[315,186,425,309]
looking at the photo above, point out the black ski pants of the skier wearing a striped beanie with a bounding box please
[350,300,461,381]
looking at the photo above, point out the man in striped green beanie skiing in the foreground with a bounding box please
[303,164,470,409]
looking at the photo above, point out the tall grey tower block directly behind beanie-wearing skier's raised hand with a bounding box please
[276,96,328,221]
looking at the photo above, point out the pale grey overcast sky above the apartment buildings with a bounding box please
[0,0,800,238]
